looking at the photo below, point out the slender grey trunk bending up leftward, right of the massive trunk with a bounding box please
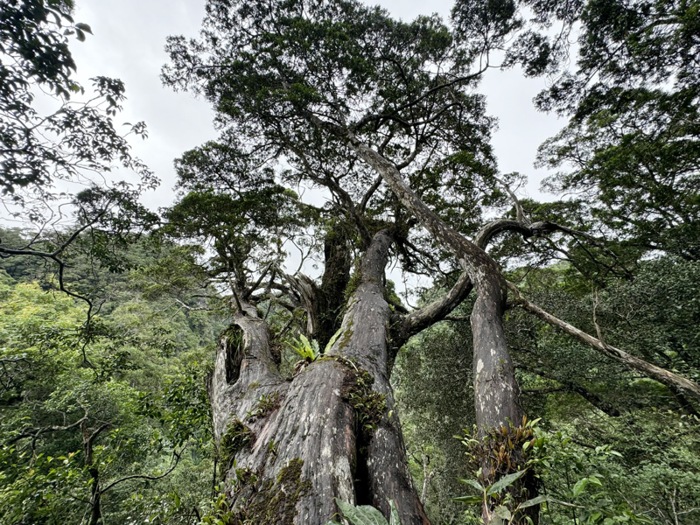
[346,137,538,525]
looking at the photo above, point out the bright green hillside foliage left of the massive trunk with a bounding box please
[0,235,219,524]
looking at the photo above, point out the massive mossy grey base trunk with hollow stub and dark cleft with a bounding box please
[210,232,428,525]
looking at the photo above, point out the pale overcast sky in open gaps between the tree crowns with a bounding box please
[71,0,561,207]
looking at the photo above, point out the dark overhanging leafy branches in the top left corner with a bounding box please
[0,0,151,203]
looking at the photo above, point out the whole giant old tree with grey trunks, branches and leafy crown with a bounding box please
[163,0,700,524]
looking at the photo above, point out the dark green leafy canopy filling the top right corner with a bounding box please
[453,0,700,260]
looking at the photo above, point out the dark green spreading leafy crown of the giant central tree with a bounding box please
[163,0,503,282]
